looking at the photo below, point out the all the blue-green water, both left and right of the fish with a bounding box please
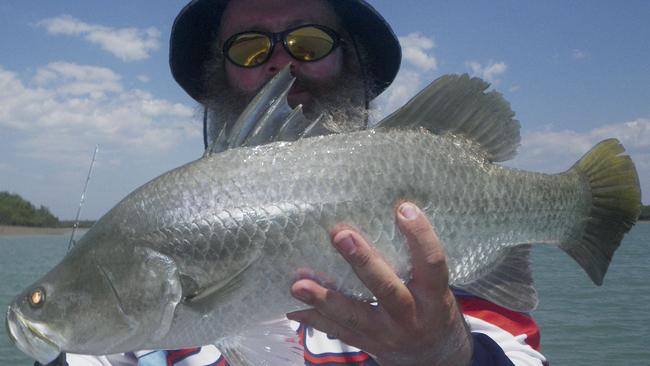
[0,224,650,366]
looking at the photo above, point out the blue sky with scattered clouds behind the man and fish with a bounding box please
[0,0,650,219]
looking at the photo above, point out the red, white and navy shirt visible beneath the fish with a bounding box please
[45,294,547,366]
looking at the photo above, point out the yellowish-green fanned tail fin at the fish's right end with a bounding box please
[560,139,641,285]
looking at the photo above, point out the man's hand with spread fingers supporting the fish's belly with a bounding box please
[287,202,472,366]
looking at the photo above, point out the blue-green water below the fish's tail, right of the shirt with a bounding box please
[533,223,650,366]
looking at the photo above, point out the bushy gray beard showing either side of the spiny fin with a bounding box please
[203,75,368,143]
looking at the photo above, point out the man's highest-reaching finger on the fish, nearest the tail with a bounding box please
[397,202,449,290]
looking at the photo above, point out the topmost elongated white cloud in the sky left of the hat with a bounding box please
[37,15,160,61]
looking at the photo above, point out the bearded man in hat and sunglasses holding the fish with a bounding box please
[35,0,545,366]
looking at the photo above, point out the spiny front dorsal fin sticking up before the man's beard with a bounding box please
[205,65,325,156]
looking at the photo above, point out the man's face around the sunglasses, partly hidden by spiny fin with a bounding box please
[219,0,343,109]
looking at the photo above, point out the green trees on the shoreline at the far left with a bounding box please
[0,192,59,227]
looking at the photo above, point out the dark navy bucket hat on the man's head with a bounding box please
[169,0,402,101]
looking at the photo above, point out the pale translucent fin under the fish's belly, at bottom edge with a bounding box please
[215,319,305,366]
